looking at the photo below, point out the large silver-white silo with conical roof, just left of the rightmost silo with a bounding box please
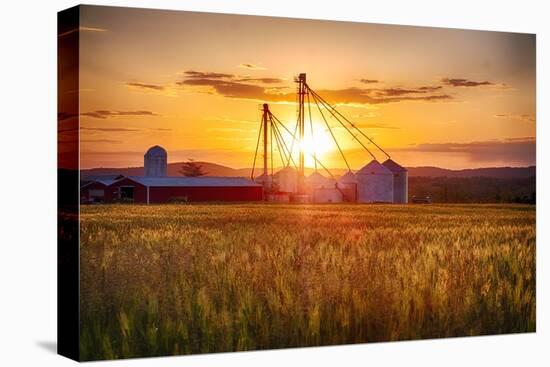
[355,159,393,203]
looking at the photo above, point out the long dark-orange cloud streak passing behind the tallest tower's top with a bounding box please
[176,71,452,105]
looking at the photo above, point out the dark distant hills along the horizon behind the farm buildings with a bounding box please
[81,162,536,179]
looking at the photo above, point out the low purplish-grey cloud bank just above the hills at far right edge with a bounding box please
[394,137,536,164]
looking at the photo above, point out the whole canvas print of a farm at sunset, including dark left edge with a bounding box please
[57,5,536,361]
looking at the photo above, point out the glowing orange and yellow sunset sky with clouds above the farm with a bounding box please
[64,6,536,169]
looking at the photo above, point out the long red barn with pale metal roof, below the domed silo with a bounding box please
[101,176,263,204]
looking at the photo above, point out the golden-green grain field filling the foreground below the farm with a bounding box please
[80,204,535,360]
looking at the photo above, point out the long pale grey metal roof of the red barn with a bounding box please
[120,176,262,187]
